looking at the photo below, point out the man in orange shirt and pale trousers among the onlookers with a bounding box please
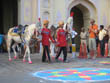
[89,19,98,59]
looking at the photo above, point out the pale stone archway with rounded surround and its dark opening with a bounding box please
[67,0,97,51]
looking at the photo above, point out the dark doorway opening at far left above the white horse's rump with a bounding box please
[0,0,18,34]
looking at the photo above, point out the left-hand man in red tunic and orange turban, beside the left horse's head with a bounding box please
[41,20,55,62]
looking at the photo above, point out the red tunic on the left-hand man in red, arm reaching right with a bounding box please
[41,28,55,46]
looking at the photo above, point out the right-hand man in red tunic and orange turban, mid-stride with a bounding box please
[55,21,68,62]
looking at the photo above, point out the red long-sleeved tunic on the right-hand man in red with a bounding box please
[57,28,67,47]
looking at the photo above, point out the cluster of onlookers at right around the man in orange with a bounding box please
[80,19,110,59]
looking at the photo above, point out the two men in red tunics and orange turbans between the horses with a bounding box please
[41,20,68,62]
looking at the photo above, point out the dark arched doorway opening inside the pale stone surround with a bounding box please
[70,4,90,51]
